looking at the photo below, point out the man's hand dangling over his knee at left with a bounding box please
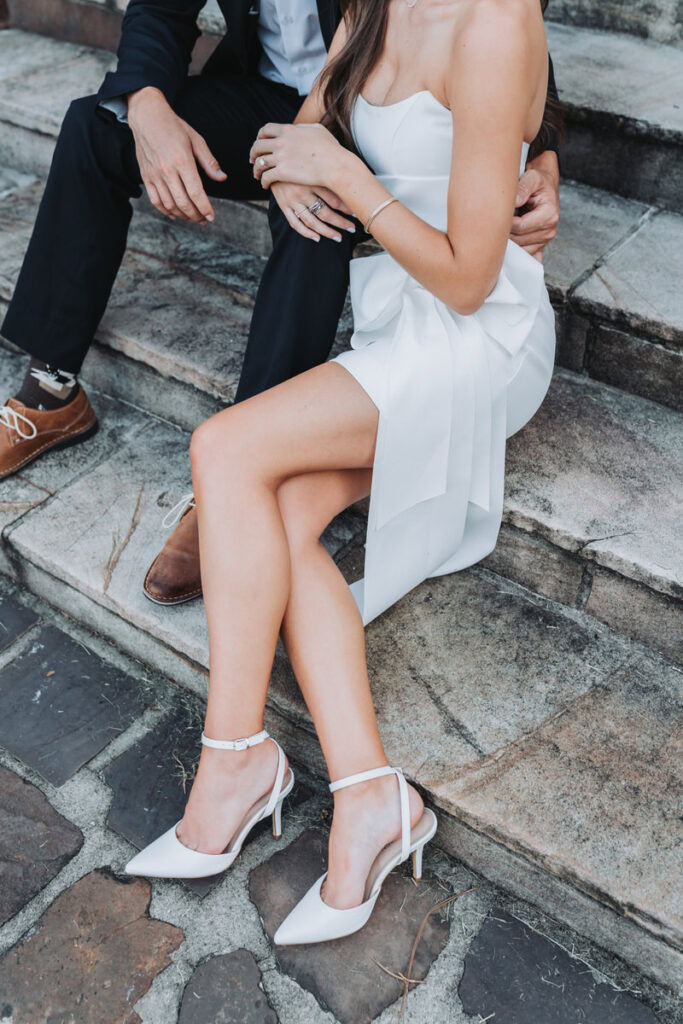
[128,86,227,224]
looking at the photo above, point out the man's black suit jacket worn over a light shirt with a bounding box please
[97,0,557,150]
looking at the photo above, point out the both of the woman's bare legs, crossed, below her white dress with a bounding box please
[178,367,422,906]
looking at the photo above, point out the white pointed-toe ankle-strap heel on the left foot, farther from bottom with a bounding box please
[125,729,294,879]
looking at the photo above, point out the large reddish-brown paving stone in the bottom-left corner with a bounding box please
[0,871,183,1024]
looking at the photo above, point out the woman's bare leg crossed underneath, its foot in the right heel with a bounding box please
[279,469,423,908]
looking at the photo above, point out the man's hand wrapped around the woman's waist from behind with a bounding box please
[510,151,560,262]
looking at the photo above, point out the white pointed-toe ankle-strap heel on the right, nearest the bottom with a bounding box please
[273,765,436,946]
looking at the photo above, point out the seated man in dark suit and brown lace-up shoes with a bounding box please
[0,0,559,603]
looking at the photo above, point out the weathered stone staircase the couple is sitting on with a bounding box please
[0,0,683,988]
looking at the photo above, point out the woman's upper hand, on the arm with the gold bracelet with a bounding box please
[249,124,347,188]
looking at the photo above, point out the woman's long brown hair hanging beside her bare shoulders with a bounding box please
[321,0,563,157]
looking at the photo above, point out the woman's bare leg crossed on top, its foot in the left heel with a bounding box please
[178,364,377,853]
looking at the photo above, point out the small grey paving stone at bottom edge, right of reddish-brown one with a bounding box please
[178,949,278,1024]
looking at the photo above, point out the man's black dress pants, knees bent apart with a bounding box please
[0,75,354,399]
